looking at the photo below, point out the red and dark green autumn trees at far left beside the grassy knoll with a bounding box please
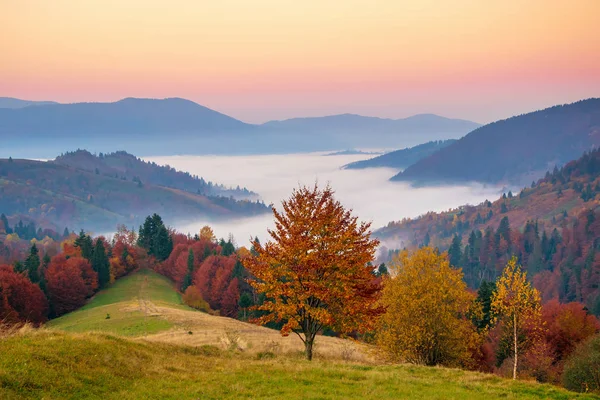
[0,227,146,324]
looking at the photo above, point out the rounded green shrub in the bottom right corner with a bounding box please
[563,335,600,392]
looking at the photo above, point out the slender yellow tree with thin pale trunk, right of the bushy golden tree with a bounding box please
[491,257,542,379]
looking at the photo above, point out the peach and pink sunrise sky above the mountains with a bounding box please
[0,0,600,123]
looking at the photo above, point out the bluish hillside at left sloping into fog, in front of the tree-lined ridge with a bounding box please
[0,155,268,232]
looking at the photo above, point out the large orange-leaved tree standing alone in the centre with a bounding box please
[242,185,382,360]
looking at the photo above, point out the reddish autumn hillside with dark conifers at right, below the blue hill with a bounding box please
[377,150,600,315]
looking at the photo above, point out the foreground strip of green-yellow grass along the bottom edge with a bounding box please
[0,330,595,400]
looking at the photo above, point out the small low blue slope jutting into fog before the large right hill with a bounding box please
[344,139,456,170]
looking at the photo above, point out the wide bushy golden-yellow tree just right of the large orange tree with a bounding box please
[376,247,480,367]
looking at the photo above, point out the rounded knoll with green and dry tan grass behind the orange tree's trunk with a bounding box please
[47,269,369,360]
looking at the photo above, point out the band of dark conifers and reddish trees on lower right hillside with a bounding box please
[448,210,600,315]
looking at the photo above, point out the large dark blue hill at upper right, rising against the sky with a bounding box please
[392,99,600,188]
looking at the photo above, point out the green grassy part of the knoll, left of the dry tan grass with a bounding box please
[47,270,187,336]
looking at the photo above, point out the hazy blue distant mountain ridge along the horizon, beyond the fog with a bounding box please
[0,98,479,158]
